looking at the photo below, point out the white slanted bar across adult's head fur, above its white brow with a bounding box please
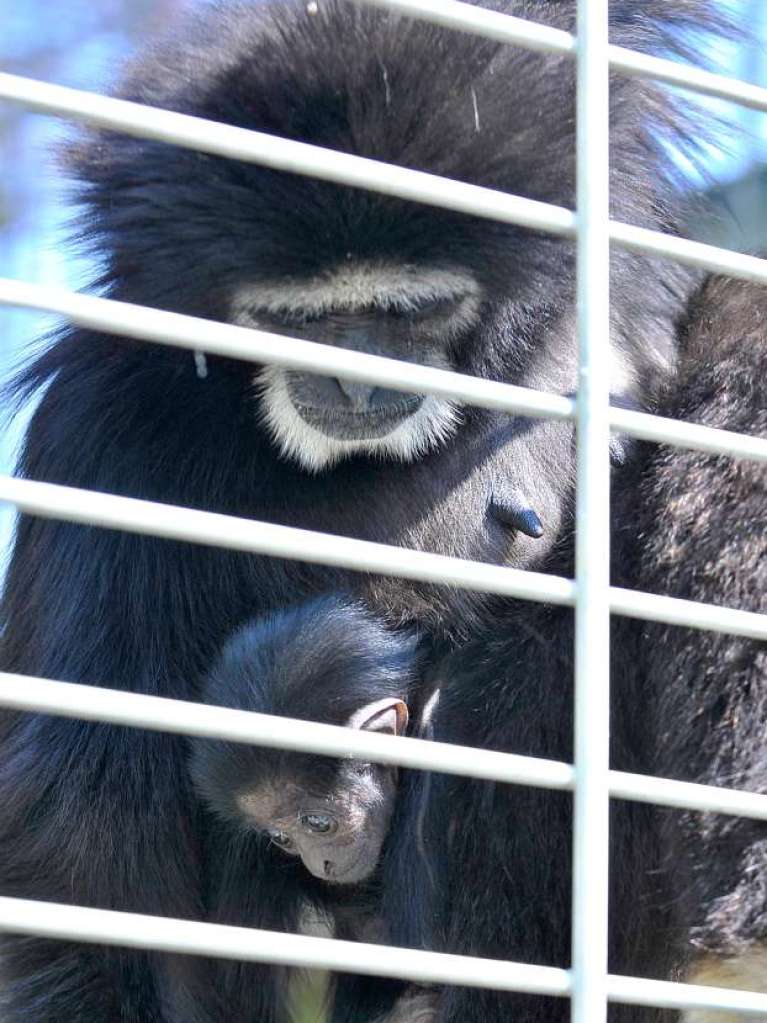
[0,74,767,283]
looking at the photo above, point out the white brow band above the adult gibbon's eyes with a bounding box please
[231,263,482,318]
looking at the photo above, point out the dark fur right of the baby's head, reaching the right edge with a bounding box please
[374,278,767,1023]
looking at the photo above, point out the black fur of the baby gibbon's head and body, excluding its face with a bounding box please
[168,596,418,1023]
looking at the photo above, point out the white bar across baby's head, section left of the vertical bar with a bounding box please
[0,672,576,789]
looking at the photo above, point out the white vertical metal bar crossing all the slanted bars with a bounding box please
[572,0,610,1023]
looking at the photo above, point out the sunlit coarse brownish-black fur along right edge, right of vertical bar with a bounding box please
[638,279,767,976]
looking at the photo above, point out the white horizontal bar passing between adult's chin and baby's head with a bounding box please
[0,475,767,639]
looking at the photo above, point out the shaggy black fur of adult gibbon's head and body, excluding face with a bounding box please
[0,0,740,1023]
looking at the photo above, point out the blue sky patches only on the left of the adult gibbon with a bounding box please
[0,0,191,556]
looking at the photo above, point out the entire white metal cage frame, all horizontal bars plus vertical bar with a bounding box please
[0,0,767,1023]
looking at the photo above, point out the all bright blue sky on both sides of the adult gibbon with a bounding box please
[0,0,767,549]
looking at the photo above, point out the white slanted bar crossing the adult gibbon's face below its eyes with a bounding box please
[0,277,767,461]
